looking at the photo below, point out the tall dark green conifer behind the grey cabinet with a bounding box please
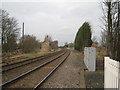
[75,22,92,50]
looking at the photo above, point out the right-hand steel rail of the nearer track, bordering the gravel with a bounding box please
[32,52,71,90]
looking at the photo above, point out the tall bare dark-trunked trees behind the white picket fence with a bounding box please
[102,0,120,60]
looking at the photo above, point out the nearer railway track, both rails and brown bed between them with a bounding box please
[1,51,70,89]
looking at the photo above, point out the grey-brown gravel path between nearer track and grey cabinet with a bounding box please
[41,51,83,88]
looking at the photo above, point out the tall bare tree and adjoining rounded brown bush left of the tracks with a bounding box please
[1,10,40,53]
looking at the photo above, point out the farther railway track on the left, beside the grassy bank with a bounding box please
[0,51,62,73]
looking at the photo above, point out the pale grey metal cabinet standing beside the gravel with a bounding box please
[84,47,96,71]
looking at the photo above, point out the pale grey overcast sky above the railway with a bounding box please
[2,2,102,45]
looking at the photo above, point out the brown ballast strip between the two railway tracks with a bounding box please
[2,50,65,83]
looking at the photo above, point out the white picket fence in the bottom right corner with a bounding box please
[104,57,120,90]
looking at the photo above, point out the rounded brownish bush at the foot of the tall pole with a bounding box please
[19,35,40,53]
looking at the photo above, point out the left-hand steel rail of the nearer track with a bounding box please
[0,51,67,88]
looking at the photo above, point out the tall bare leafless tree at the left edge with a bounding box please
[1,10,20,52]
